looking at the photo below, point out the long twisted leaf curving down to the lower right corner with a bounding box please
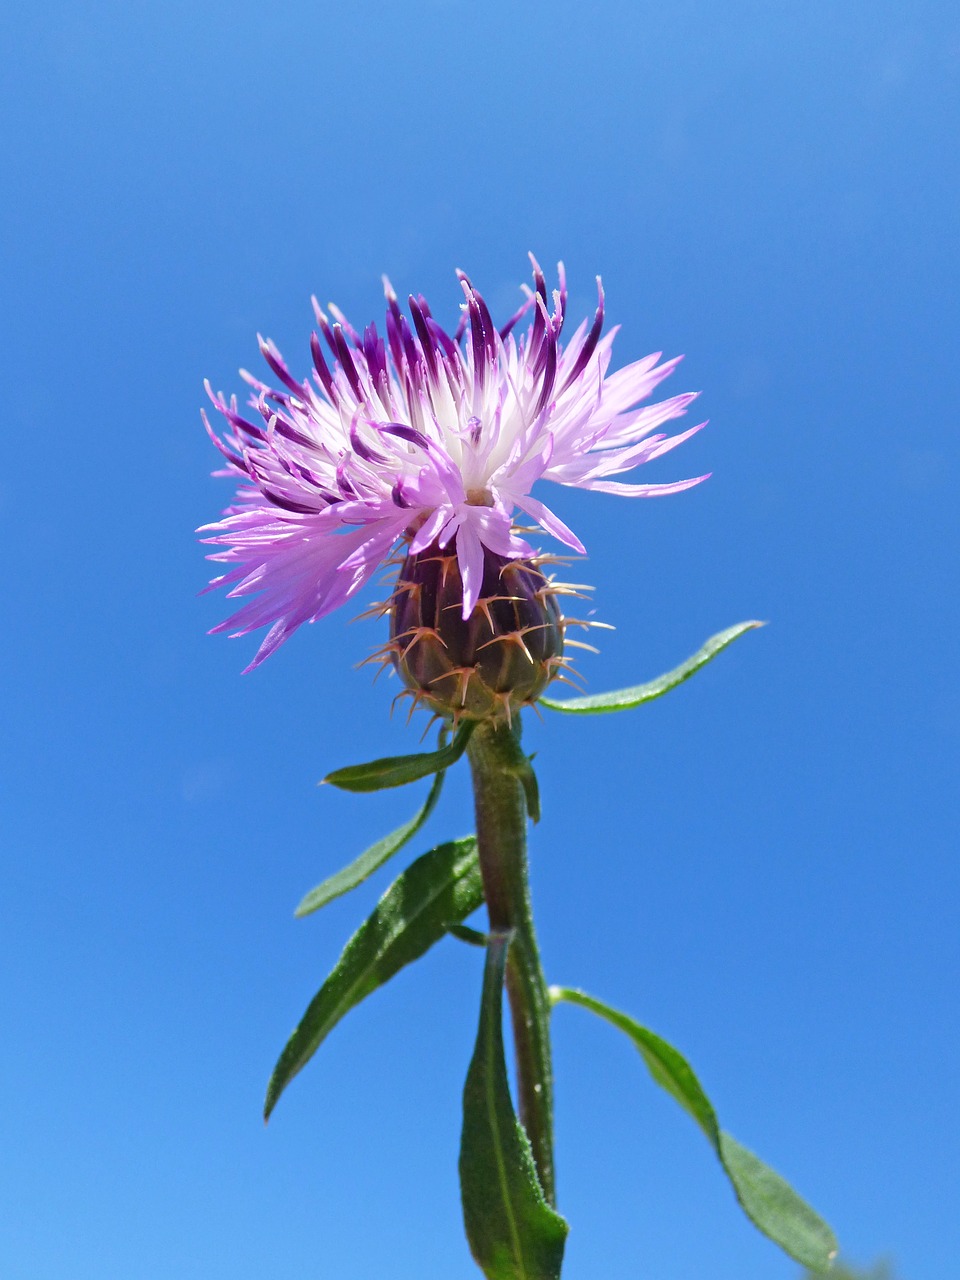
[550,987,837,1272]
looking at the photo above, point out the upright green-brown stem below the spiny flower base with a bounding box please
[467,722,557,1204]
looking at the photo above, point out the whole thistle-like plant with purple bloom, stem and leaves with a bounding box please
[202,259,836,1280]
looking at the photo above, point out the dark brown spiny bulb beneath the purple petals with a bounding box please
[389,543,566,721]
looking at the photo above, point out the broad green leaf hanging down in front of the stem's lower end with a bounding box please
[460,933,567,1280]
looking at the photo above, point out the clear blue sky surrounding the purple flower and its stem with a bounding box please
[0,0,960,1280]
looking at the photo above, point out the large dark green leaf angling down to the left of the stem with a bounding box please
[264,836,484,1119]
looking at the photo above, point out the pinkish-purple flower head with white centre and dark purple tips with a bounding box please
[201,256,707,671]
